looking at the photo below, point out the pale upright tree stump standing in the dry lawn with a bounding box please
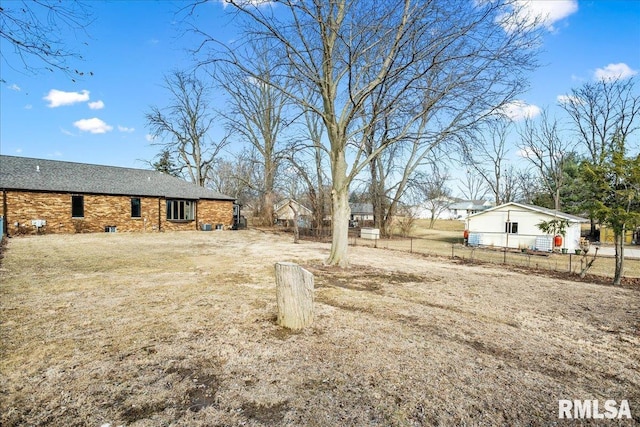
[276,262,313,329]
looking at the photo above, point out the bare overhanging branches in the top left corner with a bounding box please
[0,0,93,81]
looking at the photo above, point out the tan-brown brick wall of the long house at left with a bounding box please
[2,191,233,235]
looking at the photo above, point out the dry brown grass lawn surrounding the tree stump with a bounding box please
[0,231,640,426]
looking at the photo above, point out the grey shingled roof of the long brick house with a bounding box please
[0,155,234,200]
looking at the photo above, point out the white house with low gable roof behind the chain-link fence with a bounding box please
[467,202,589,252]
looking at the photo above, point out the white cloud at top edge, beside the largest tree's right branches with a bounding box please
[498,0,578,32]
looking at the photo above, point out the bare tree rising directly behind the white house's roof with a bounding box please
[518,110,575,210]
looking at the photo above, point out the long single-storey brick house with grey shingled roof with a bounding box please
[0,156,234,235]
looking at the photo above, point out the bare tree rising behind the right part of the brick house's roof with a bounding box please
[145,71,229,187]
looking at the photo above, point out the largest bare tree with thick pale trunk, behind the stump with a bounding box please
[194,0,537,266]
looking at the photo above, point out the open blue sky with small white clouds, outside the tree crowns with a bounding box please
[0,0,640,168]
